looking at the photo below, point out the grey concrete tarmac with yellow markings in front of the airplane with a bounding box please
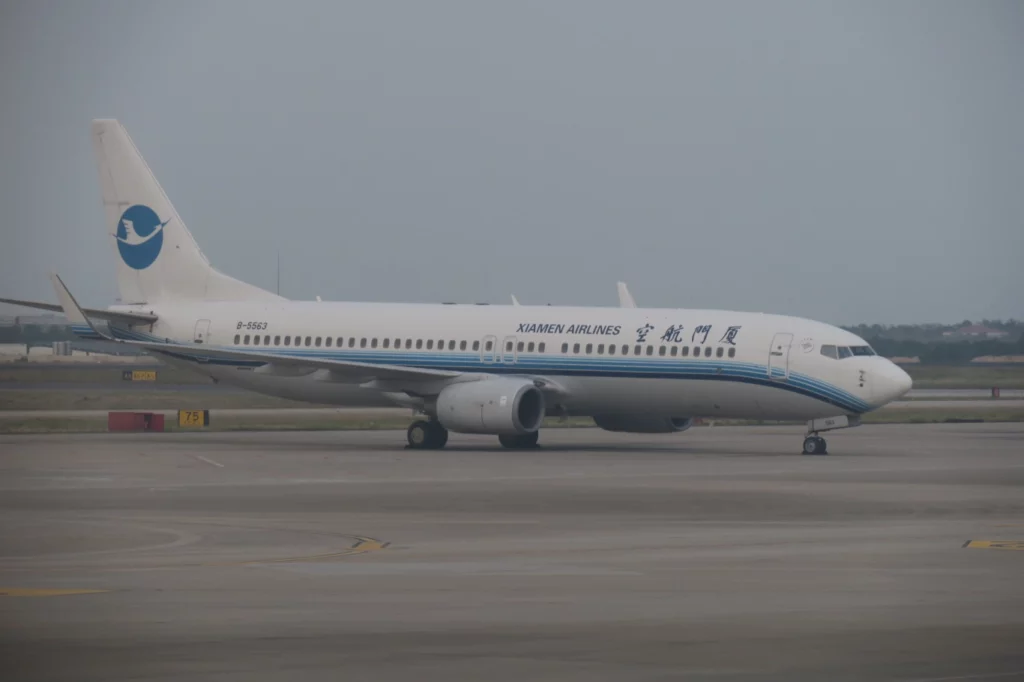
[0,424,1024,682]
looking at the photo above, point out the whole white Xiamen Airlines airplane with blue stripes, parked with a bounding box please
[0,120,911,454]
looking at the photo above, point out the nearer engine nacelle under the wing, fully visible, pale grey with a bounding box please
[436,377,544,435]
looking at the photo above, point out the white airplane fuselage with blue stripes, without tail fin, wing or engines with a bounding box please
[97,301,899,420]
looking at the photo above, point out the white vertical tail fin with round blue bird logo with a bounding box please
[92,119,280,303]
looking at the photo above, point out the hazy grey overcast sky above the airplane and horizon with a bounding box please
[0,0,1024,324]
